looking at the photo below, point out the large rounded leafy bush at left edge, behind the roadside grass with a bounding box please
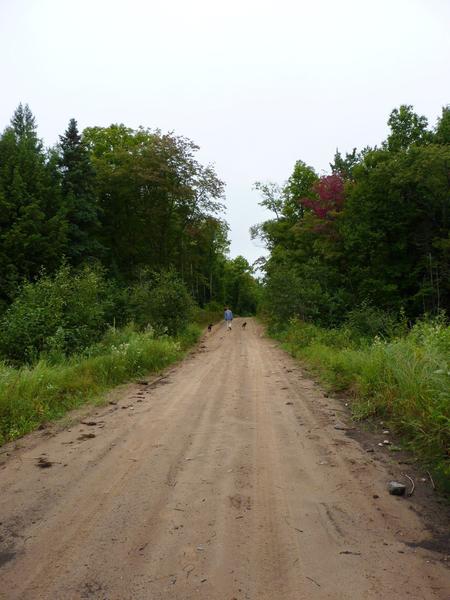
[0,266,113,363]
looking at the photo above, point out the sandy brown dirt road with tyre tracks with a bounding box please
[0,321,450,600]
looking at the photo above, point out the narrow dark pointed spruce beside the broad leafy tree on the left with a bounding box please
[59,119,102,265]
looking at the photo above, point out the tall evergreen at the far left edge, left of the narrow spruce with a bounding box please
[0,104,66,301]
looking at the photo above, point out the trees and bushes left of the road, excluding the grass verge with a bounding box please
[0,104,257,360]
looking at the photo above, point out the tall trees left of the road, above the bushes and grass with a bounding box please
[0,105,243,320]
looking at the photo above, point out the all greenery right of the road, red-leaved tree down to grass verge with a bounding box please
[252,106,450,490]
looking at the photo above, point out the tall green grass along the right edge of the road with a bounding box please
[271,320,450,492]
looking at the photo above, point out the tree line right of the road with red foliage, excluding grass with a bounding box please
[255,105,450,327]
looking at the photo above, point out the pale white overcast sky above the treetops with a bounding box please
[0,0,450,261]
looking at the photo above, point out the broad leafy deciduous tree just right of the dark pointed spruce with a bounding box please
[83,125,228,302]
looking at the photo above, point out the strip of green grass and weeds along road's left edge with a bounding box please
[0,325,201,444]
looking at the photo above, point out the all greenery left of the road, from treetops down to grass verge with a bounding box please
[0,105,259,444]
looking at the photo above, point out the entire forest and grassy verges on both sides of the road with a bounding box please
[0,105,450,482]
